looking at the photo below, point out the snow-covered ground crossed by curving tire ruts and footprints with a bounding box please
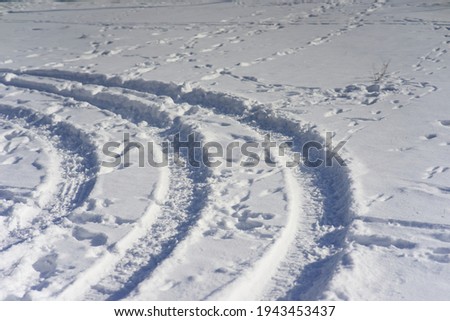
[0,0,450,300]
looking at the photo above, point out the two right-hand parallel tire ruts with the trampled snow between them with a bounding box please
[0,69,352,300]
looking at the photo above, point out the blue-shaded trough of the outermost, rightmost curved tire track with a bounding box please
[3,70,352,299]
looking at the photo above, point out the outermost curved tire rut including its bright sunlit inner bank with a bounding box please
[1,70,352,299]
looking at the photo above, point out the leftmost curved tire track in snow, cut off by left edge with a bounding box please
[0,104,98,252]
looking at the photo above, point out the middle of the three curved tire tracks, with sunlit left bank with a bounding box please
[0,72,207,299]
